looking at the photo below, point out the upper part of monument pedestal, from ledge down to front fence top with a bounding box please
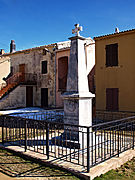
[62,92,94,126]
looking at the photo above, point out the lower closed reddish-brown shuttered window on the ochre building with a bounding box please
[106,88,119,111]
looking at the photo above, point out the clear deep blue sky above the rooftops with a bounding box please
[0,0,135,52]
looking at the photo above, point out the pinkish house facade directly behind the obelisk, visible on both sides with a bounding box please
[56,38,95,107]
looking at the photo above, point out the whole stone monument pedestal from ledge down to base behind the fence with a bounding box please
[62,92,94,149]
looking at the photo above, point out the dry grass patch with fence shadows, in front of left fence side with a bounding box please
[0,149,79,180]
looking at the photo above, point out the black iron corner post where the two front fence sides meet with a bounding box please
[87,127,90,172]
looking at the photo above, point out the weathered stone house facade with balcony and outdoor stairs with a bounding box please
[0,44,55,109]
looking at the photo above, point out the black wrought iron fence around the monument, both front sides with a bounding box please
[0,112,135,172]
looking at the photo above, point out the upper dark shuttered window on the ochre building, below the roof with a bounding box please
[106,43,118,67]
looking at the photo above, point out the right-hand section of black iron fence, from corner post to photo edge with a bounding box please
[90,116,135,167]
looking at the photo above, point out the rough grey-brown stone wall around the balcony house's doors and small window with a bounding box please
[10,46,55,107]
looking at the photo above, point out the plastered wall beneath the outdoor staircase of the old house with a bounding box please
[0,86,26,110]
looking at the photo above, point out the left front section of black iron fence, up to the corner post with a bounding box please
[1,114,89,172]
